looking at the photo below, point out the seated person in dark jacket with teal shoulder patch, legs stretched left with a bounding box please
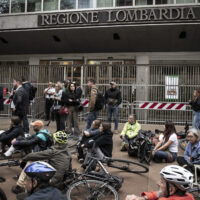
[11,120,51,156]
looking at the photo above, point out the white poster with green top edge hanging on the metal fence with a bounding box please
[165,76,179,100]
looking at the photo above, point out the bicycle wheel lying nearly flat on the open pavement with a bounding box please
[107,159,149,174]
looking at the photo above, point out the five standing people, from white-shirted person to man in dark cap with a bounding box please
[44,79,122,135]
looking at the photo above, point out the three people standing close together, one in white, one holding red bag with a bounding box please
[44,81,82,135]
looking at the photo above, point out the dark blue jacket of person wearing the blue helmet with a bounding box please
[24,187,66,200]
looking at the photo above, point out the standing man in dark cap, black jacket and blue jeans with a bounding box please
[105,81,122,133]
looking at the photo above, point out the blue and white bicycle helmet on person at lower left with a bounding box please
[24,161,56,181]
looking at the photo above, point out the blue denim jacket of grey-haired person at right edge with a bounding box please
[184,141,200,164]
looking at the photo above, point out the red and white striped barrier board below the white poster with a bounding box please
[139,102,186,110]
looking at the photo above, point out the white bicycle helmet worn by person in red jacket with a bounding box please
[160,165,193,191]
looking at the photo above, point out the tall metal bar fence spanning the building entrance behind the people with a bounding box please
[0,63,200,124]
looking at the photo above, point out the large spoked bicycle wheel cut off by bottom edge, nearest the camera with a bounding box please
[66,180,119,200]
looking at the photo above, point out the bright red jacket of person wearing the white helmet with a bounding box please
[142,191,194,200]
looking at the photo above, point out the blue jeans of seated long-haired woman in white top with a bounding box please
[153,151,177,163]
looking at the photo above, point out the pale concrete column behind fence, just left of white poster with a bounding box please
[136,56,150,123]
